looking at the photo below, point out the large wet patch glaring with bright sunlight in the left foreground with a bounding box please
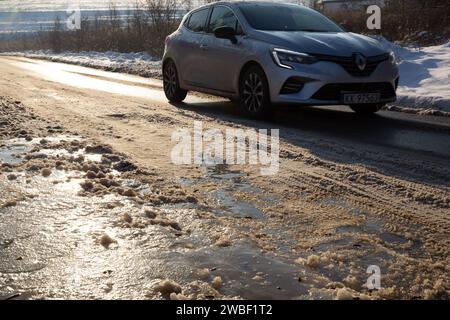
[0,165,135,278]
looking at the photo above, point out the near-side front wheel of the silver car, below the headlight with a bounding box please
[239,66,273,118]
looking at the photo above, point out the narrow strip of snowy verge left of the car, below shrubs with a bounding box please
[0,50,161,78]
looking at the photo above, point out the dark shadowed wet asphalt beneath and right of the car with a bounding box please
[174,102,450,159]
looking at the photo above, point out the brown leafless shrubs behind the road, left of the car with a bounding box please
[0,0,185,57]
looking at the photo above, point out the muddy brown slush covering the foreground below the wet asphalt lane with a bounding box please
[0,98,450,300]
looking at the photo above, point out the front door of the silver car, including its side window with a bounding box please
[203,5,244,93]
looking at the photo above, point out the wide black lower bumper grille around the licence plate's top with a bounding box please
[312,82,395,101]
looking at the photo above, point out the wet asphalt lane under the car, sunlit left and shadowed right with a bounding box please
[0,57,450,159]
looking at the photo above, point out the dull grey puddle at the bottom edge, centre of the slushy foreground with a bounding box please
[179,242,326,300]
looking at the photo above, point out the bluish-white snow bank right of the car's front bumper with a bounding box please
[378,38,450,112]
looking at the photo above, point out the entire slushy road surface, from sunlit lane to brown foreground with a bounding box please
[0,57,450,299]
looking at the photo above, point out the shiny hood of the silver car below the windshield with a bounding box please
[251,30,386,57]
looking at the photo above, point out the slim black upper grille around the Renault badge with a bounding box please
[313,54,389,77]
